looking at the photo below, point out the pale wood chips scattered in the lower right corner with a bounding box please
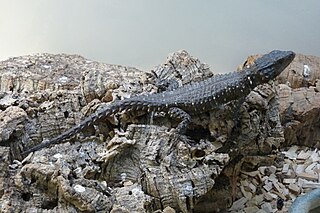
[228,146,320,213]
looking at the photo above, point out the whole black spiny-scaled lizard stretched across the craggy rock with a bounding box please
[22,50,295,155]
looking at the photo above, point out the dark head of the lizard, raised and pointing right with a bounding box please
[254,50,295,83]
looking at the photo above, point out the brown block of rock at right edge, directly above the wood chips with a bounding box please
[278,85,320,147]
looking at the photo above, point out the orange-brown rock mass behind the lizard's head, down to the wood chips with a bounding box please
[240,54,320,147]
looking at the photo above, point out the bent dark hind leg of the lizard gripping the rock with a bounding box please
[168,107,191,134]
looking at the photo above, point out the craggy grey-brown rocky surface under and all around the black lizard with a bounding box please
[0,51,320,213]
